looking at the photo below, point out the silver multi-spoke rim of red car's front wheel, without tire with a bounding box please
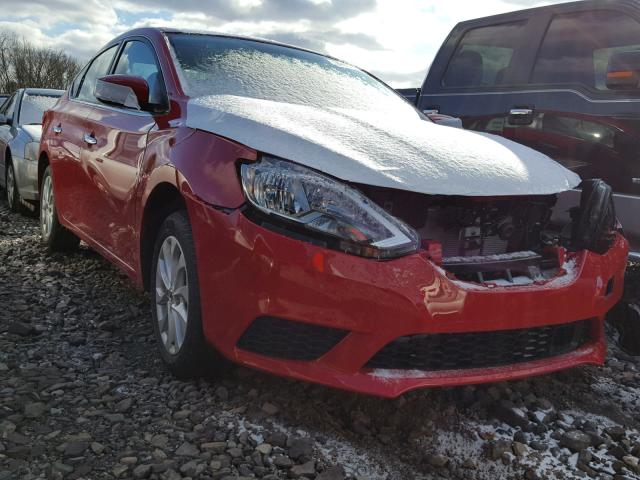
[156,236,189,355]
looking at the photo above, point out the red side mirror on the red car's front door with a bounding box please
[94,75,149,110]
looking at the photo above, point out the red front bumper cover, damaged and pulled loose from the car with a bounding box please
[188,199,628,397]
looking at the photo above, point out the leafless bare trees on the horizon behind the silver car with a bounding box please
[0,32,81,93]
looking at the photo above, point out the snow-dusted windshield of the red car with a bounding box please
[167,33,415,113]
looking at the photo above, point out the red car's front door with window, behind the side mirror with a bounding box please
[81,38,168,268]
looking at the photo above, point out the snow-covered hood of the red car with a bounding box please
[186,92,580,196]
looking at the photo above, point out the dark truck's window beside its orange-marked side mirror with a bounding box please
[531,10,640,90]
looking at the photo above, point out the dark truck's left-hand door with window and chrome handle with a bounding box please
[418,12,542,138]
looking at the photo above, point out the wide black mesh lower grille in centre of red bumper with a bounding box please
[366,320,591,371]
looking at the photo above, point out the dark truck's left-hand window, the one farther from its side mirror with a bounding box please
[442,22,527,87]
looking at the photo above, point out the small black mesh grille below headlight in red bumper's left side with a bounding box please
[237,317,349,361]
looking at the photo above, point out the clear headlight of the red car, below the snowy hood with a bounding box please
[240,156,419,259]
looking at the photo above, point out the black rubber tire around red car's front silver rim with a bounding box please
[149,210,207,377]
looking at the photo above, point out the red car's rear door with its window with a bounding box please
[50,45,118,227]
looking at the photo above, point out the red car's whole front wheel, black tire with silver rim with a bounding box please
[149,210,220,378]
